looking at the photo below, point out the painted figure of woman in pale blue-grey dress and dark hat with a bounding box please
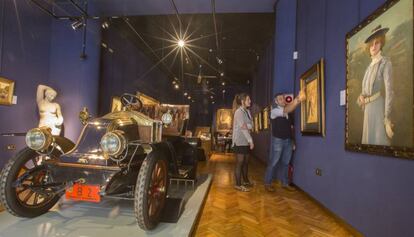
[357,25,394,146]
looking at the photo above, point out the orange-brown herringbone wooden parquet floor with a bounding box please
[195,154,353,237]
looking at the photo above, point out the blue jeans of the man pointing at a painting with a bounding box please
[265,137,293,186]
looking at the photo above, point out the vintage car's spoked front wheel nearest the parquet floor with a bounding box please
[134,152,168,230]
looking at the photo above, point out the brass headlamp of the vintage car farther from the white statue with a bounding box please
[101,130,127,156]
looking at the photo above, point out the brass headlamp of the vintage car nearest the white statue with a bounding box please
[25,127,53,151]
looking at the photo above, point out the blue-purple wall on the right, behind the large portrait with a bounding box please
[275,0,414,237]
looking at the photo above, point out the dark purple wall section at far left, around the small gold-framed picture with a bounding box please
[0,0,51,168]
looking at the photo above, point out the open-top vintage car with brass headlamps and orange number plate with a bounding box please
[0,94,197,230]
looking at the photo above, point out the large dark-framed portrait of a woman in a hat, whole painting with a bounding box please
[345,0,414,159]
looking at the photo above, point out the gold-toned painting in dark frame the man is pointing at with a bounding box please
[300,59,325,136]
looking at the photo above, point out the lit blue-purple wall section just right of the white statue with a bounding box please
[48,20,101,141]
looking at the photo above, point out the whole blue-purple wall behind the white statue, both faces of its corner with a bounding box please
[0,0,100,168]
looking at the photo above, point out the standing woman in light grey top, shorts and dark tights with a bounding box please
[232,93,254,192]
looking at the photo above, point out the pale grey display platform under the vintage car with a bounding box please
[0,174,212,237]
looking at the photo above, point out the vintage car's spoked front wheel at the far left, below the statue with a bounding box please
[0,148,60,217]
